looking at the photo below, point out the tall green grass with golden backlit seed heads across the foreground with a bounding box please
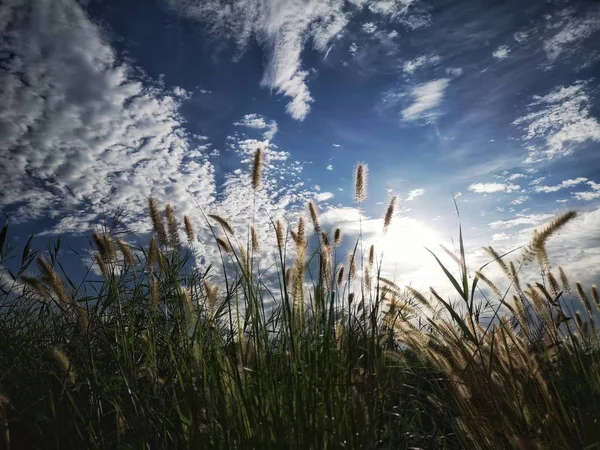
[0,152,600,449]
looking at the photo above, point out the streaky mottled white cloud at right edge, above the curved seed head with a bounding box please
[513,82,600,163]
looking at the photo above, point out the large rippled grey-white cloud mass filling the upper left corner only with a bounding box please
[0,0,214,231]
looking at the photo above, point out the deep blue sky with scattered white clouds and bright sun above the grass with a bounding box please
[0,0,600,296]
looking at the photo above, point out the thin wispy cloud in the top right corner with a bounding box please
[544,8,600,63]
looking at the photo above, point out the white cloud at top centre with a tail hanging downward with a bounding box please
[164,0,428,120]
